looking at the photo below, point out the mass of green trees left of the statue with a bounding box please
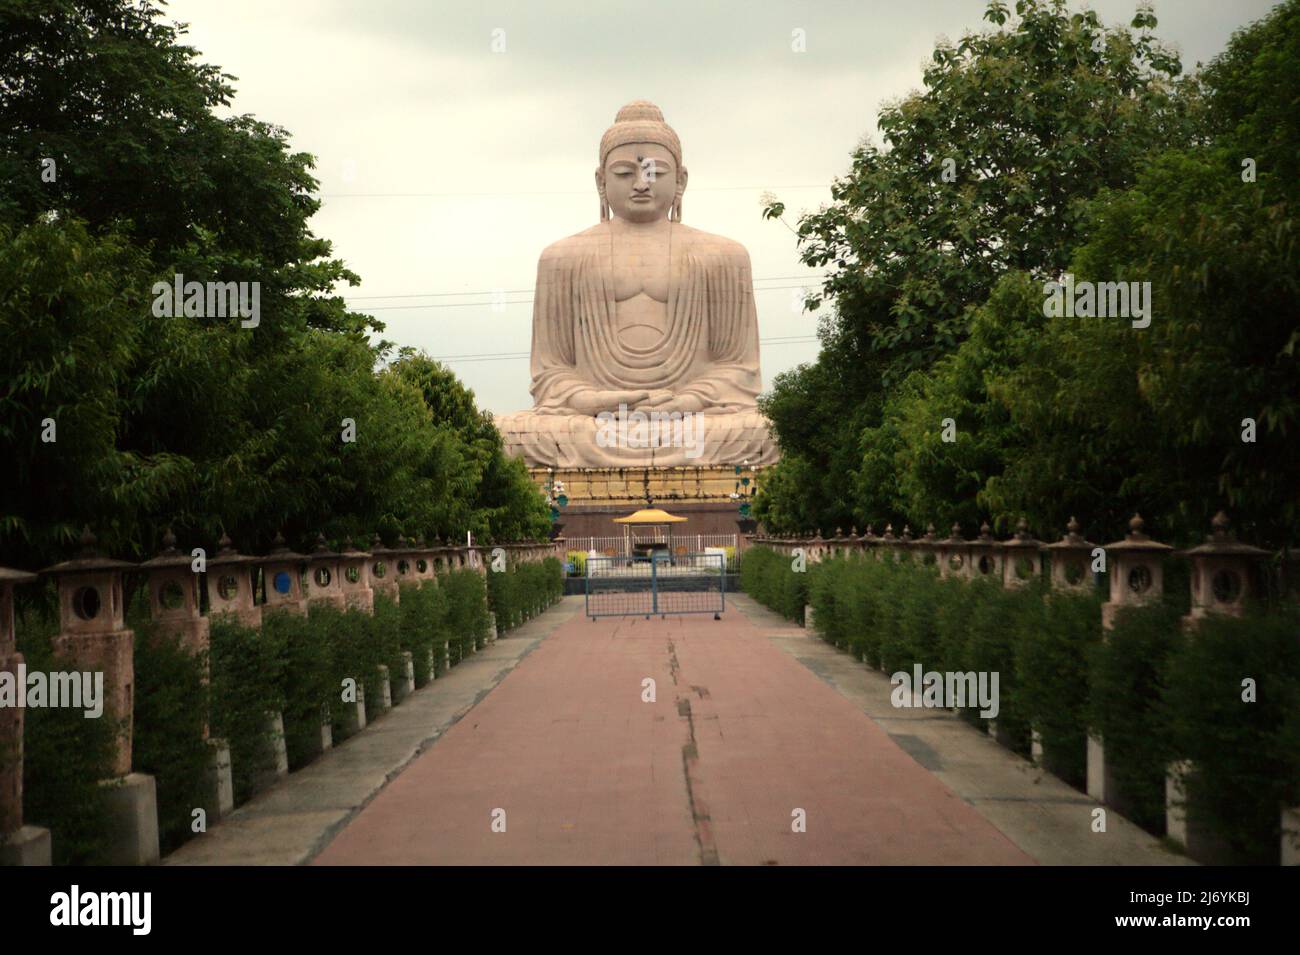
[0,0,549,567]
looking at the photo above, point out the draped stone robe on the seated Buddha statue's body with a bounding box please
[497,222,777,468]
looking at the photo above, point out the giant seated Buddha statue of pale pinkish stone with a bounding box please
[497,100,777,468]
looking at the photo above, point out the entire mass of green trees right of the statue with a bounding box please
[755,0,1300,543]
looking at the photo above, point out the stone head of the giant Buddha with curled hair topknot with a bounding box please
[595,100,686,222]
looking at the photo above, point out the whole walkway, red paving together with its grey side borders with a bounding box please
[175,595,1184,865]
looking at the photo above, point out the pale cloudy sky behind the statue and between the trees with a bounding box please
[168,0,1271,413]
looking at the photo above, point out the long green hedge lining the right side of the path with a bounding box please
[741,547,1300,864]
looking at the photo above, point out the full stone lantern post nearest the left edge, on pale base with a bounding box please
[44,528,159,865]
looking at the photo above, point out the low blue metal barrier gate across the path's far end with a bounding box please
[586,554,727,620]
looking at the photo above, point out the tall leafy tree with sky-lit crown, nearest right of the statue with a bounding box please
[764,0,1200,535]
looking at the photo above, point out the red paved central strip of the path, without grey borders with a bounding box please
[316,611,1032,865]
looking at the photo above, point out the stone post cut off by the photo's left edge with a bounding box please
[0,567,51,865]
